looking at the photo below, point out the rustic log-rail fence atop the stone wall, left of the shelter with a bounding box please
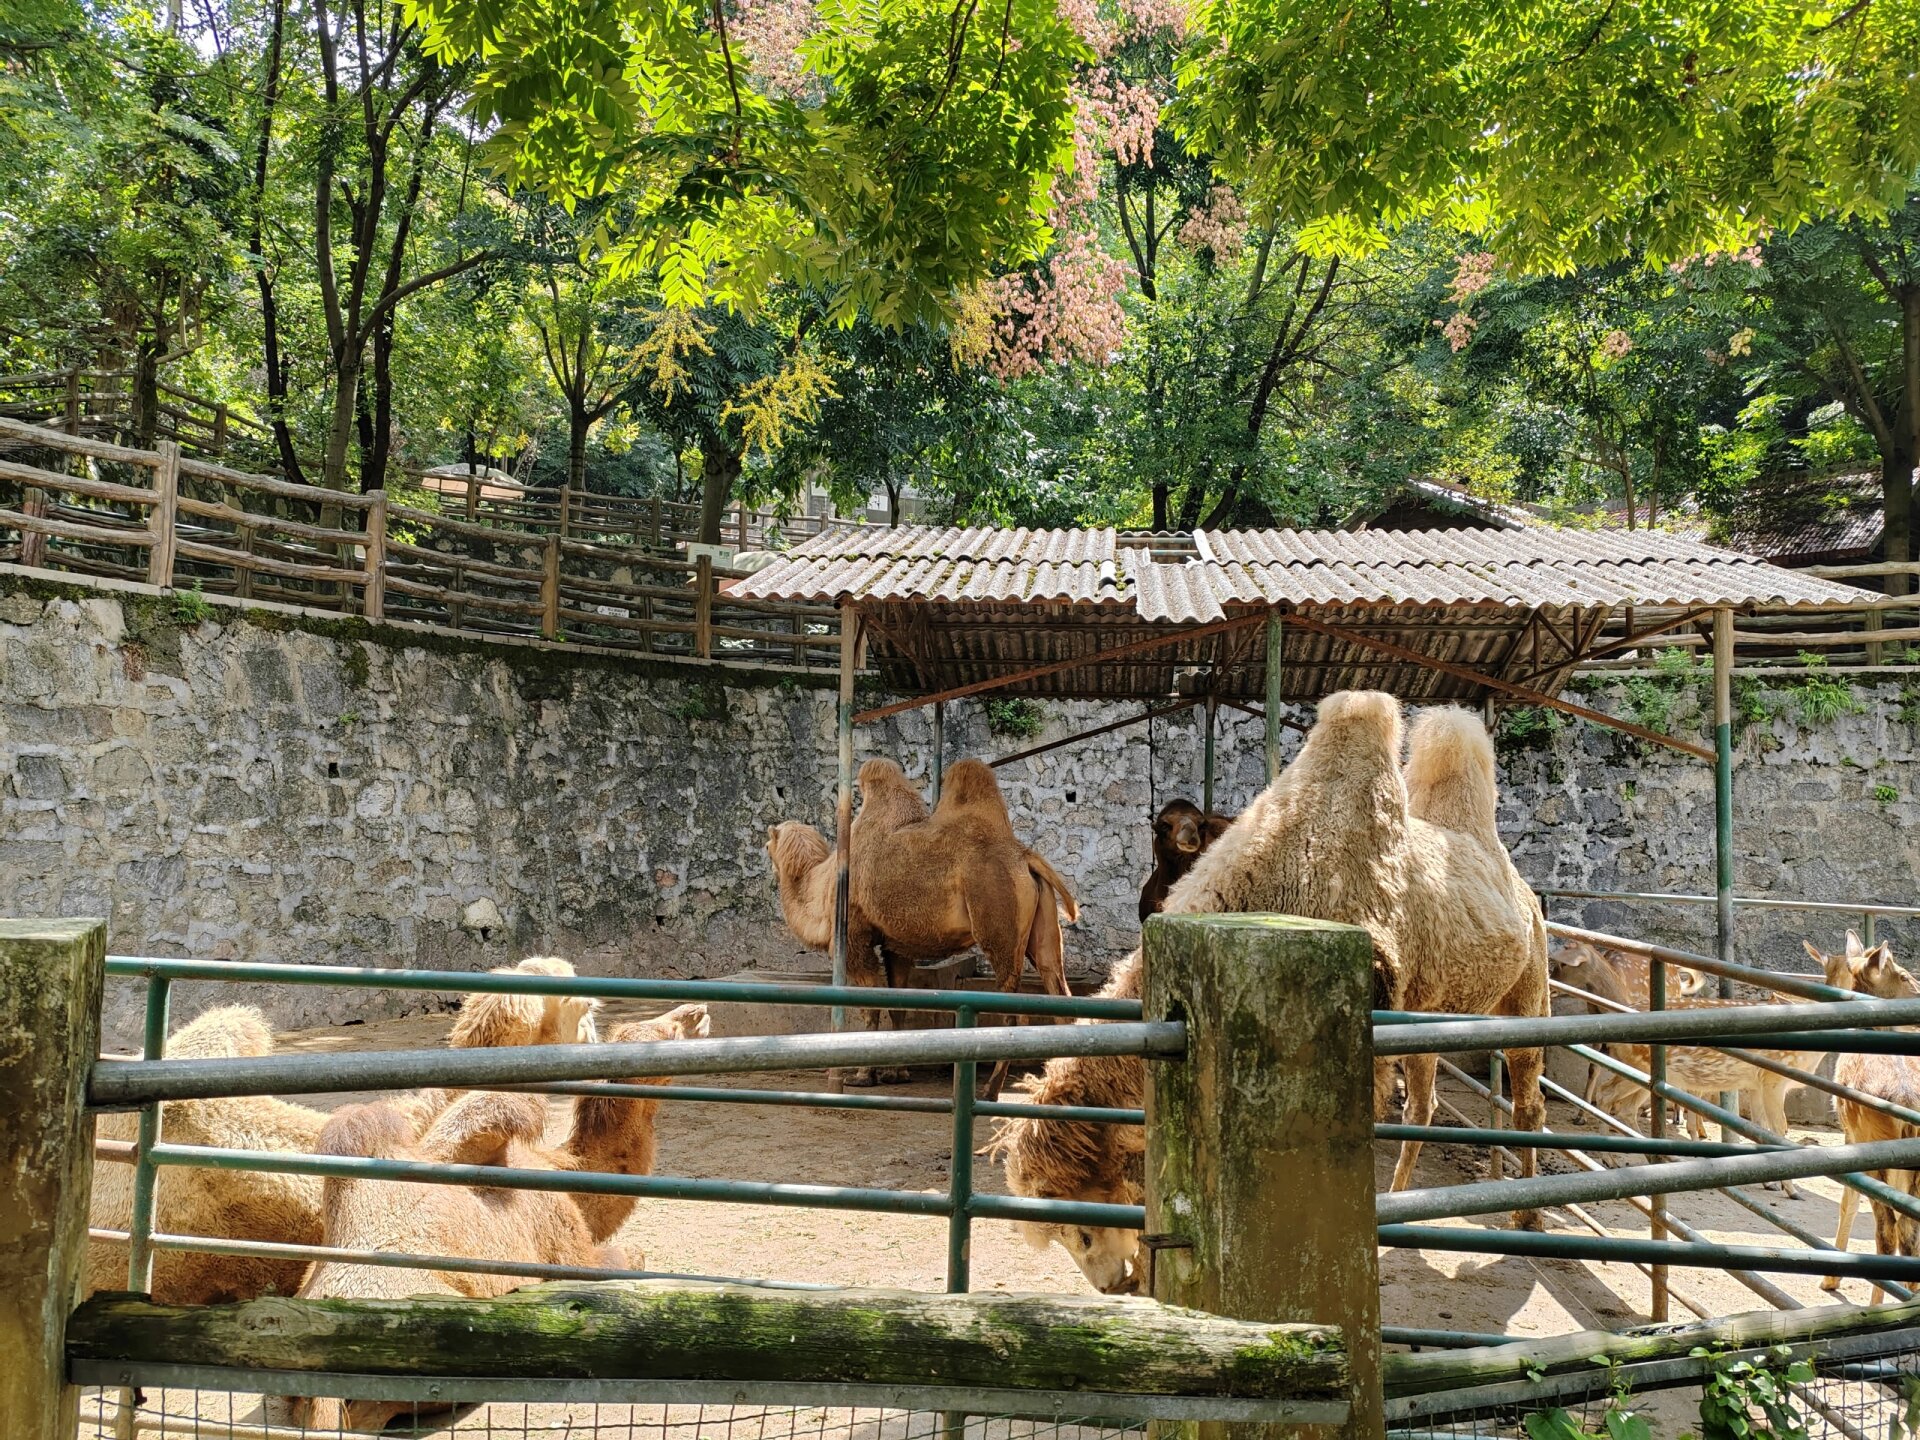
[0,419,839,668]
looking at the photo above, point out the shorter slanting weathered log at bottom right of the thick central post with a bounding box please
[1380,1300,1920,1396]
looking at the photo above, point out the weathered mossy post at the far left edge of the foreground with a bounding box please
[0,920,108,1440]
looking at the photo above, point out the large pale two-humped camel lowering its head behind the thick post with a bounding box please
[991,691,1548,1292]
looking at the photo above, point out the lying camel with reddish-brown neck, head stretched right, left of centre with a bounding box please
[294,1004,710,1430]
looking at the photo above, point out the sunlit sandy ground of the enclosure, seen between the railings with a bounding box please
[83,1012,1904,1440]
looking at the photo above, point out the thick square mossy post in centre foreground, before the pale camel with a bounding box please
[1144,914,1386,1440]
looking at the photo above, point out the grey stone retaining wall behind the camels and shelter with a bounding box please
[0,578,1920,1041]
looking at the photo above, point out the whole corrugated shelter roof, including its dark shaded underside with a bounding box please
[730,526,1874,701]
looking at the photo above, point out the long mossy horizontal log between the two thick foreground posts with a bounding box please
[67,1281,1348,1400]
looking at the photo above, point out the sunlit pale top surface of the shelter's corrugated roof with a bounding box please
[732,526,1870,624]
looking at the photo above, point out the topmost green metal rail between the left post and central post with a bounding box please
[97,956,1140,1020]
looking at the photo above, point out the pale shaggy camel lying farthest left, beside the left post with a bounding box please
[86,956,597,1306]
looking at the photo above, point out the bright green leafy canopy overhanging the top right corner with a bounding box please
[1179,0,1920,271]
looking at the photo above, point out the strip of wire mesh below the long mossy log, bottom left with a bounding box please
[79,1380,1146,1440]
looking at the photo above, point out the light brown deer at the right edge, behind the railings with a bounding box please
[1801,929,1920,1306]
